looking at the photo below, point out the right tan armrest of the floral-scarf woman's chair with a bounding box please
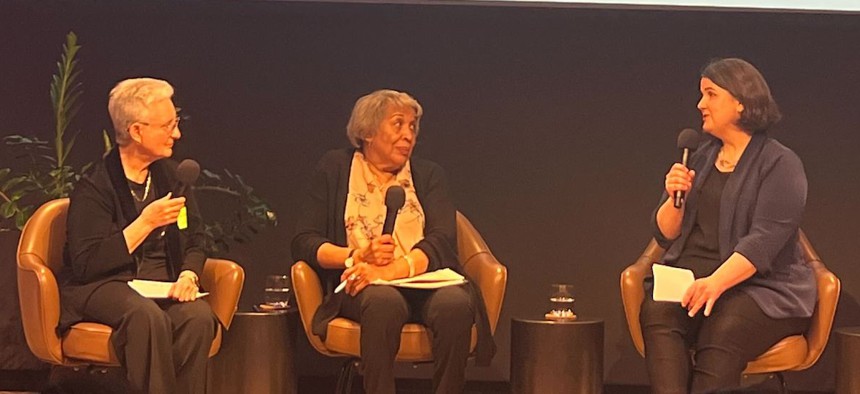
[463,252,508,333]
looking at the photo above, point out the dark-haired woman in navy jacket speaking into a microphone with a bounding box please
[640,59,816,393]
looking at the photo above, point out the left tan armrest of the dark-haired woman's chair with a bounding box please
[621,239,663,357]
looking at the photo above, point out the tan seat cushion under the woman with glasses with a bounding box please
[63,322,119,365]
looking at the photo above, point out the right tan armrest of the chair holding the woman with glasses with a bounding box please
[200,259,245,329]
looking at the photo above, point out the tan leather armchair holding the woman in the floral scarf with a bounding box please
[292,212,508,392]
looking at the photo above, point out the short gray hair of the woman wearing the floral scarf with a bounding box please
[346,89,424,148]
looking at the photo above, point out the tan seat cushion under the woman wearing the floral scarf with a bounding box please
[325,317,478,362]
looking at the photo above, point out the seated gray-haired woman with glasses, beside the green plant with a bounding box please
[58,78,217,394]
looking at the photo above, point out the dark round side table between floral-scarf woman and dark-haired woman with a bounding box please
[511,318,603,394]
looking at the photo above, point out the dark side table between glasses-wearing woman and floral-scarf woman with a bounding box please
[207,309,298,394]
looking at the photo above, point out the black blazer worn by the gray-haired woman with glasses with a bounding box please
[57,148,206,333]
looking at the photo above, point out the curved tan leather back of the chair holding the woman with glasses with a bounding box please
[18,198,69,364]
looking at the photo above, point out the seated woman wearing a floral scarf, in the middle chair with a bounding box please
[292,90,492,394]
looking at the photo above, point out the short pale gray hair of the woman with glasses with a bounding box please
[108,78,173,146]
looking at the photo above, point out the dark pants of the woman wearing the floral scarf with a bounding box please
[340,286,475,394]
